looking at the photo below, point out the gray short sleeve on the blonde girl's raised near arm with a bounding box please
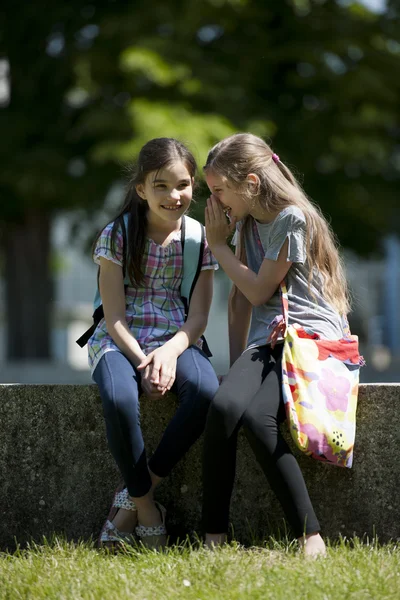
[265,207,307,264]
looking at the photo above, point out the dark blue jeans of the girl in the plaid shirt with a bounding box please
[93,346,218,498]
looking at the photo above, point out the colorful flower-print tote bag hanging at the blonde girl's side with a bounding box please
[269,282,364,467]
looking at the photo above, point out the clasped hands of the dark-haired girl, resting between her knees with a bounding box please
[137,346,177,399]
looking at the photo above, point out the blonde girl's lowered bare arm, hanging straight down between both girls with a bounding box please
[228,243,252,366]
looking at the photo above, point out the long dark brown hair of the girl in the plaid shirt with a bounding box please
[94,138,197,287]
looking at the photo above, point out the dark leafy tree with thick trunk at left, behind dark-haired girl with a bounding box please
[0,1,231,359]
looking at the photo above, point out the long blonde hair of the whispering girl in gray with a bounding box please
[204,133,350,314]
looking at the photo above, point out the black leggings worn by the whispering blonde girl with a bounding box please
[203,344,320,537]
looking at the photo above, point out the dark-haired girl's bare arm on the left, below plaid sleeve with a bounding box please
[99,258,146,366]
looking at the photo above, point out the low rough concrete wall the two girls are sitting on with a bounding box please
[0,384,400,549]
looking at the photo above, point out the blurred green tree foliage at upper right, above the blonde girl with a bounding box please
[104,0,400,254]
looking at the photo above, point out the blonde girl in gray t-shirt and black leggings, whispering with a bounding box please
[203,134,349,555]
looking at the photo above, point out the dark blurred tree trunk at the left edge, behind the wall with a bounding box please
[4,213,53,360]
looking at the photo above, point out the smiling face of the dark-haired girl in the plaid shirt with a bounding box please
[136,161,193,224]
